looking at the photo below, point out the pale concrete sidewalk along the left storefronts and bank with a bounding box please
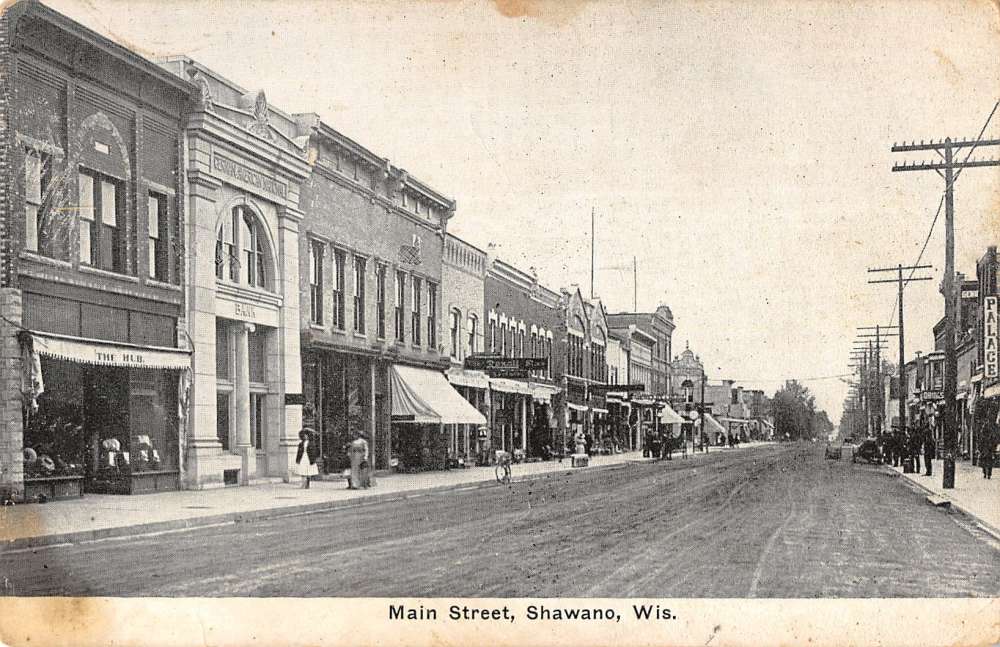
[0,443,766,550]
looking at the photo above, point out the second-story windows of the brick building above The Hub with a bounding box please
[24,149,180,283]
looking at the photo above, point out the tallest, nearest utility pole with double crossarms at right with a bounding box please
[892,129,1000,489]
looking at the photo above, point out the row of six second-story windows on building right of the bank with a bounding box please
[309,240,438,348]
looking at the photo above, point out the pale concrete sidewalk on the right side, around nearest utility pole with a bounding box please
[890,459,1000,539]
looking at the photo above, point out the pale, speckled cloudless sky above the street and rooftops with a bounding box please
[46,0,1000,421]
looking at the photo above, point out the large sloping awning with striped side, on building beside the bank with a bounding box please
[389,364,486,425]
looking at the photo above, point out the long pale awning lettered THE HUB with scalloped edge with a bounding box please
[31,331,191,370]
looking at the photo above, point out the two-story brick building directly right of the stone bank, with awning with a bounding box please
[297,115,485,472]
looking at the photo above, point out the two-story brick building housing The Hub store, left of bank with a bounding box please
[0,1,194,500]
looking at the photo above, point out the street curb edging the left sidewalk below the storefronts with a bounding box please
[0,460,642,553]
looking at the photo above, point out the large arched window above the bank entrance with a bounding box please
[215,205,272,289]
